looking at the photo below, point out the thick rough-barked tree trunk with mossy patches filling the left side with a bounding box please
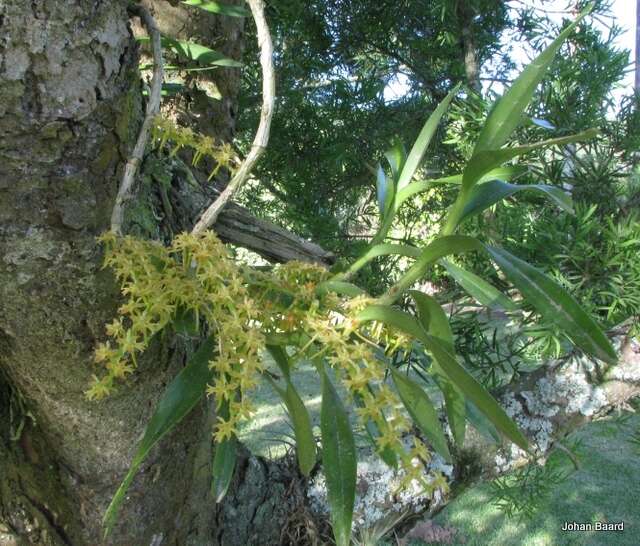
[0,0,317,546]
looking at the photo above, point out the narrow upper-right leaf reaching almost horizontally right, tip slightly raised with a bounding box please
[462,129,598,192]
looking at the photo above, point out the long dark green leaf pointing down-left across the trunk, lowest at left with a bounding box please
[103,337,215,536]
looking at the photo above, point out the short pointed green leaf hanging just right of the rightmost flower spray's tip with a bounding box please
[391,370,451,461]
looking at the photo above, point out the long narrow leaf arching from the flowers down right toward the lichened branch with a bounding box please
[357,305,528,450]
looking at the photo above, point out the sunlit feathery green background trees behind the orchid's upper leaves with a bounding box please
[239,0,640,366]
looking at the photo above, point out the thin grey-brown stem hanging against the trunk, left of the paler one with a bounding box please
[111,4,164,235]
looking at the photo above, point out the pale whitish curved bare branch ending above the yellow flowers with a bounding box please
[192,0,276,234]
